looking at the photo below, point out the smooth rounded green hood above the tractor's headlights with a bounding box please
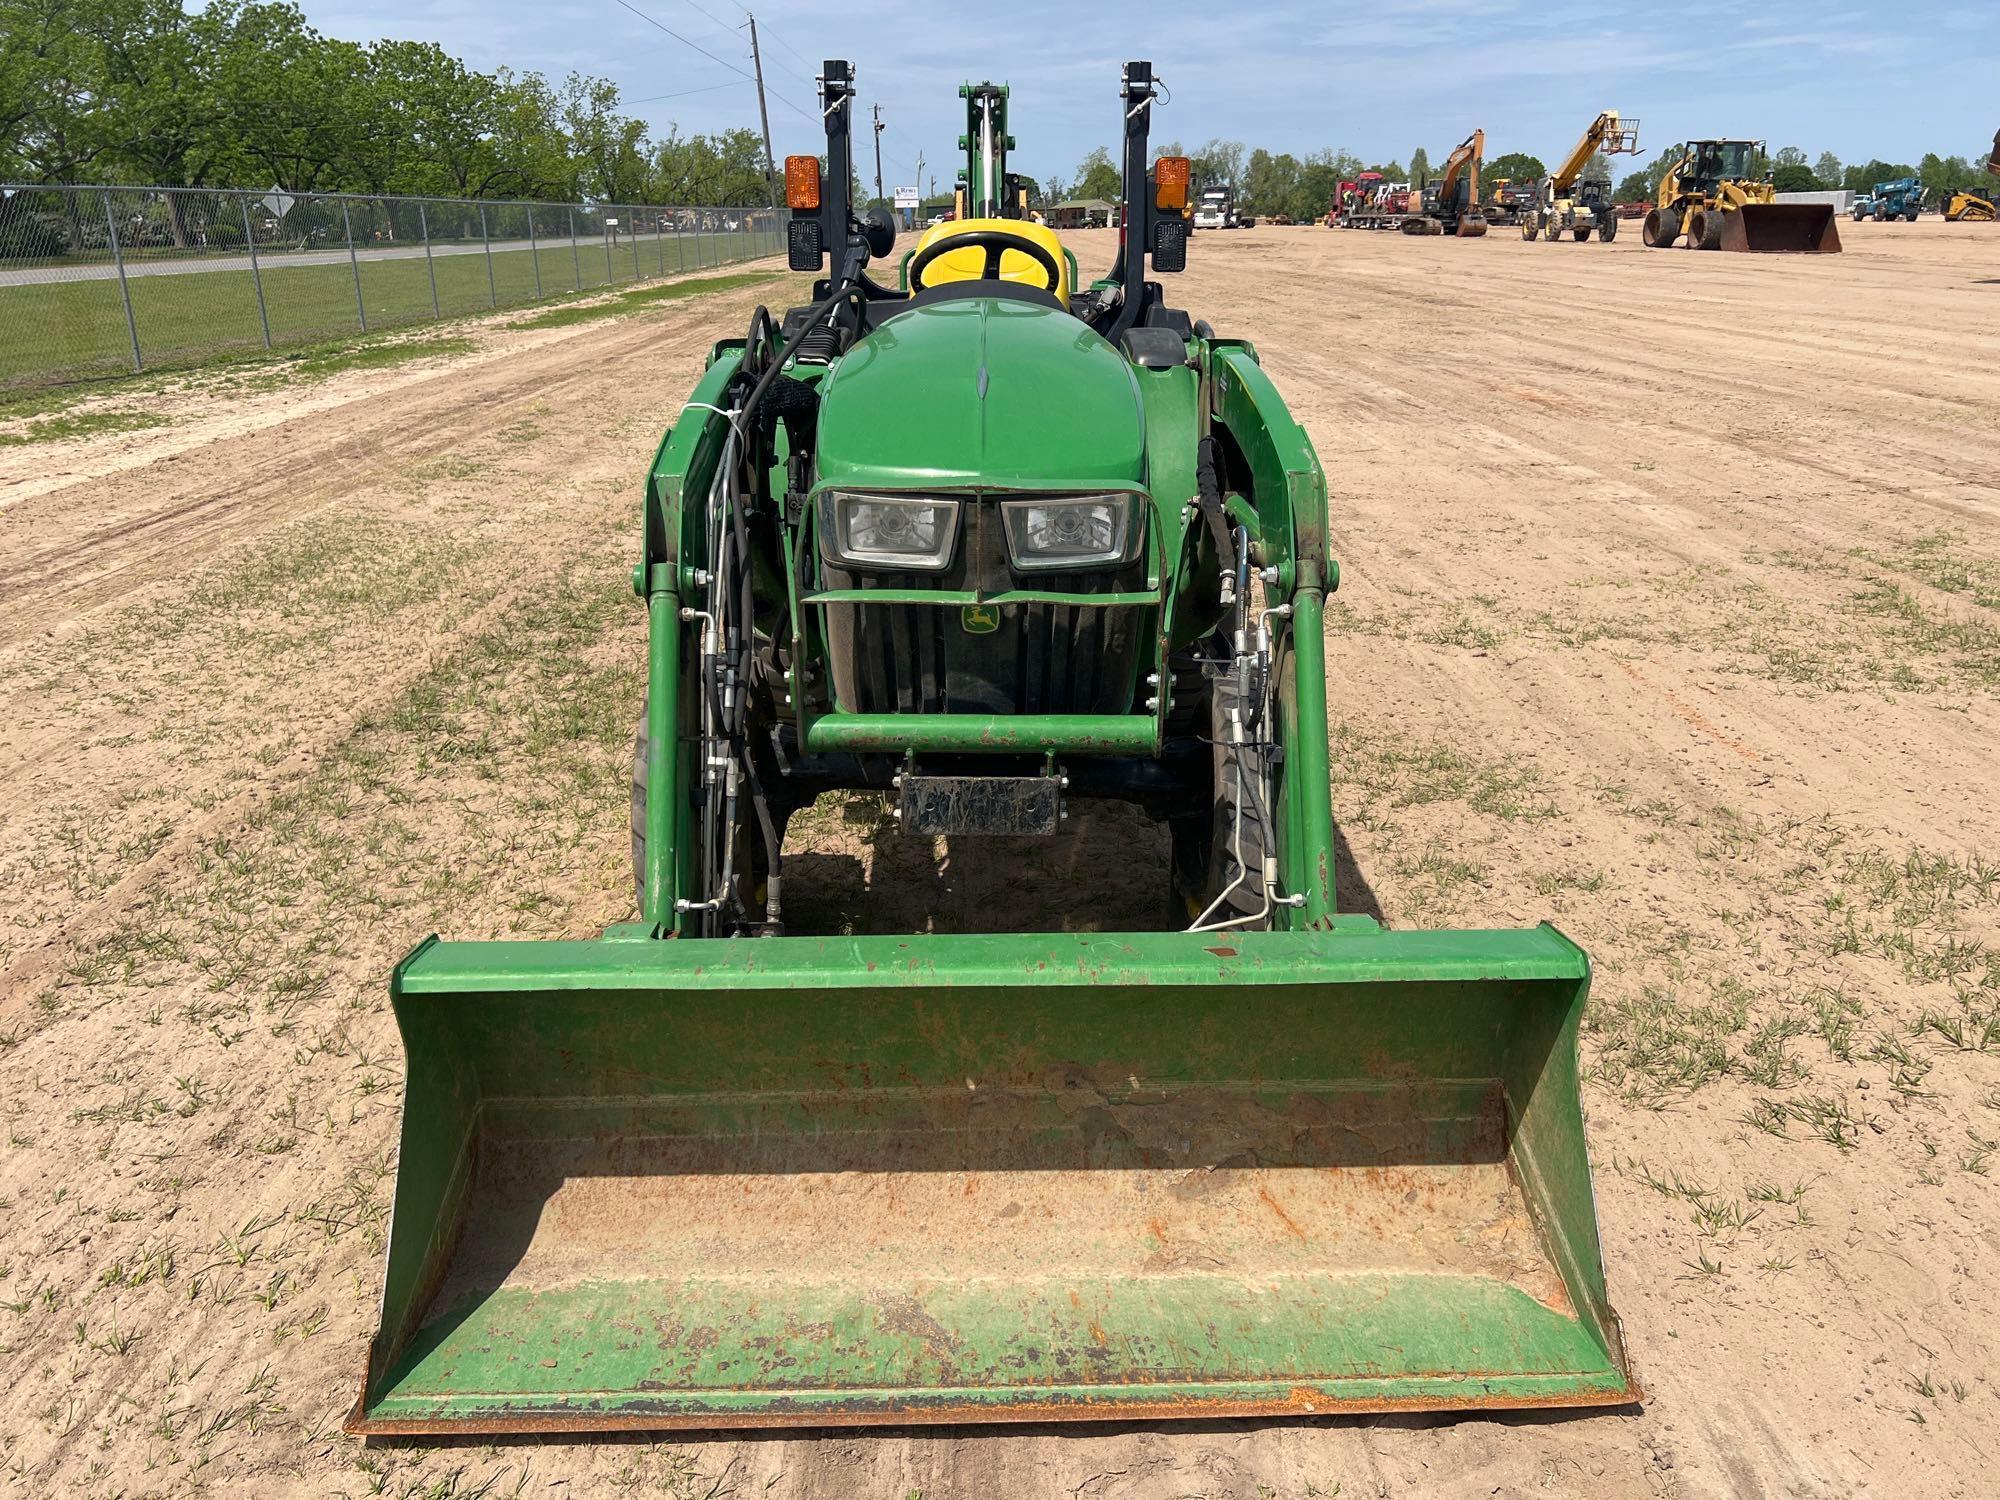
[818,296,1146,490]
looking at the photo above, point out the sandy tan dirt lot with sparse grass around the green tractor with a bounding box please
[0,220,2000,1500]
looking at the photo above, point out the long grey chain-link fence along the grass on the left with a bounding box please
[0,184,784,390]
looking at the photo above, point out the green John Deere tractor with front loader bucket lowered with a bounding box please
[348,62,1636,1434]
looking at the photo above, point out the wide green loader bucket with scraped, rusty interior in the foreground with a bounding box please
[348,918,1638,1434]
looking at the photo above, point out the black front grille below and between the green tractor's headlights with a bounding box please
[822,504,1154,714]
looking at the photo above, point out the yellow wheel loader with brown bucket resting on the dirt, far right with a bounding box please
[1640,140,1840,256]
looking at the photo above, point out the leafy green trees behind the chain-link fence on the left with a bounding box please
[0,0,768,206]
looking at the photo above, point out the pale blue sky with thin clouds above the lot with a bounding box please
[304,0,2000,184]
